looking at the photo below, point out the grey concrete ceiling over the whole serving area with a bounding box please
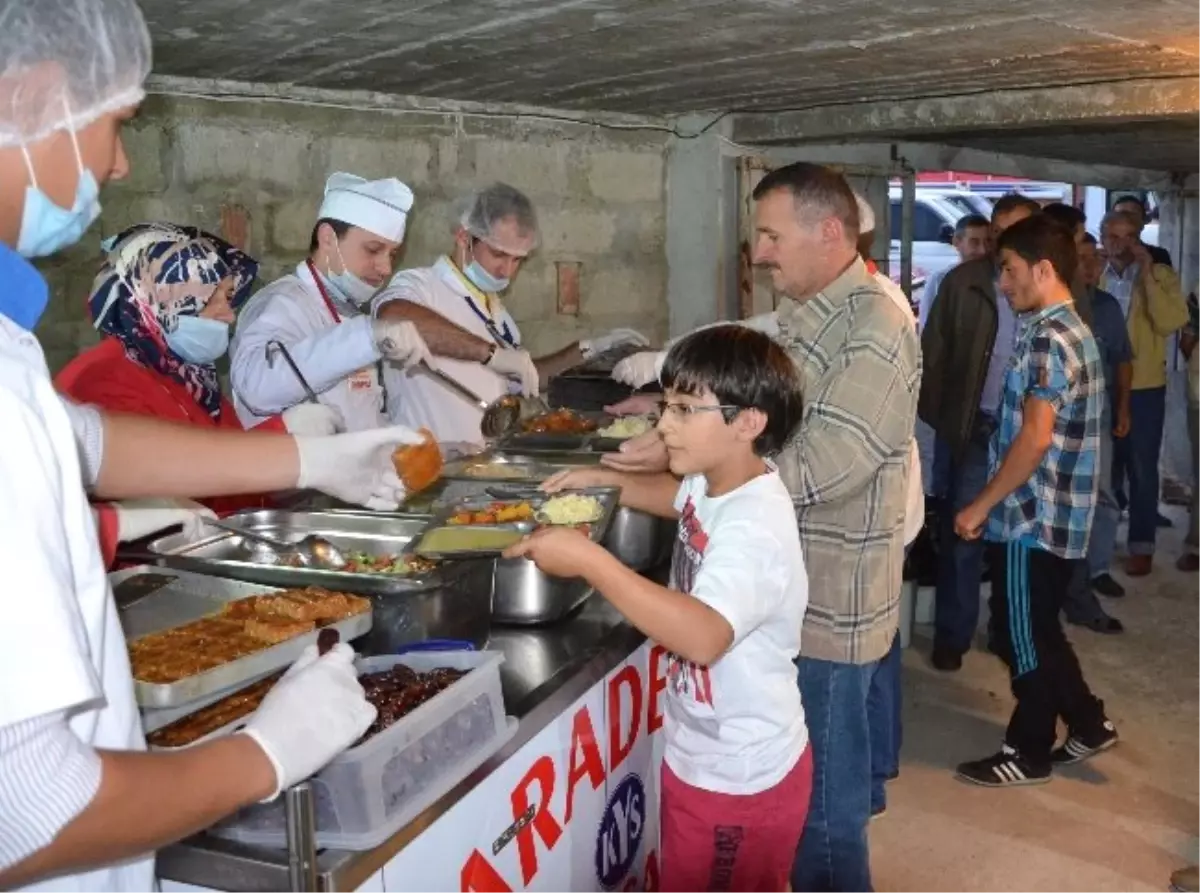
[142,0,1200,169]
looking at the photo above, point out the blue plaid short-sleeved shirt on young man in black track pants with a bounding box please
[986,304,1105,558]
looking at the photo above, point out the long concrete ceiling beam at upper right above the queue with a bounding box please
[733,77,1200,144]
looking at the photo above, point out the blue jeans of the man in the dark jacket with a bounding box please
[934,438,988,654]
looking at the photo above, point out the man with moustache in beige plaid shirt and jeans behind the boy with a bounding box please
[605,163,920,893]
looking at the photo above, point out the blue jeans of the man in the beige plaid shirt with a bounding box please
[792,657,882,893]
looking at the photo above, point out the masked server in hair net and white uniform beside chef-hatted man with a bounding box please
[372,182,649,443]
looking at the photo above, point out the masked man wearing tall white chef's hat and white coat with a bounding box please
[229,173,428,431]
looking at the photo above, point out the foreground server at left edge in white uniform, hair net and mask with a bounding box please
[0,0,427,893]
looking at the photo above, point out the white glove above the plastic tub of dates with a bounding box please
[242,642,377,803]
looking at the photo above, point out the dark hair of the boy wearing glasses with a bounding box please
[660,324,804,456]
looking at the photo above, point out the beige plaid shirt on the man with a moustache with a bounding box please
[778,260,920,664]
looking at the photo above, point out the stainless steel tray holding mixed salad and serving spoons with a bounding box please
[150,509,440,595]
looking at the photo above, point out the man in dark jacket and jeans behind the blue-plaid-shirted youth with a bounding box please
[917,194,1040,671]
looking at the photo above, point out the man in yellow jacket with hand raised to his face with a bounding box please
[1100,211,1188,576]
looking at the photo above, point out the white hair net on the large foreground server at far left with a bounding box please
[0,0,150,148]
